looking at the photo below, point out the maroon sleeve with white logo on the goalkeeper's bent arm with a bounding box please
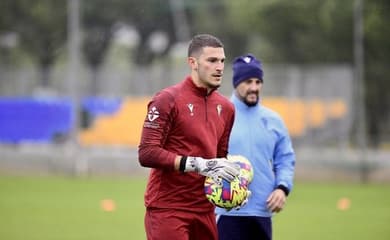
[138,91,176,170]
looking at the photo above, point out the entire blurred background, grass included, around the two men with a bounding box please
[0,0,390,240]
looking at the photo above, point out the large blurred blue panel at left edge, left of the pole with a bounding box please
[0,97,74,143]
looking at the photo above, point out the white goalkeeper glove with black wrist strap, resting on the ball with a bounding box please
[180,156,240,184]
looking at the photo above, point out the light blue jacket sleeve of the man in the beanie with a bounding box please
[273,117,295,191]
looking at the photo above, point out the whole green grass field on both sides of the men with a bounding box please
[0,176,390,240]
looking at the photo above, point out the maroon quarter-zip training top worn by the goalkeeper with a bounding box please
[138,76,234,212]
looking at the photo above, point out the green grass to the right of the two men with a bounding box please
[274,183,390,240]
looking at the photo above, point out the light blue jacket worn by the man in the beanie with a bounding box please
[216,94,295,217]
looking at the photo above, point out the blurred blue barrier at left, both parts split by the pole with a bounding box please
[0,97,122,144]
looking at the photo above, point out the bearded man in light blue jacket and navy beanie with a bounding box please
[216,54,295,240]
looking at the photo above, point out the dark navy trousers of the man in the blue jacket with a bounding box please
[217,216,272,240]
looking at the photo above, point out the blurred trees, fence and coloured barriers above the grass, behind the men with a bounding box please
[0,0,390,182]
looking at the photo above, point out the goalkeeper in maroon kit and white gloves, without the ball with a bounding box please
[138,34,239,240]
